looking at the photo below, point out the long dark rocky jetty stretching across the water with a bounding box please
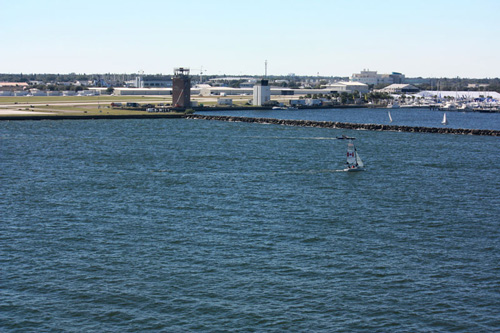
[186,114,500,136]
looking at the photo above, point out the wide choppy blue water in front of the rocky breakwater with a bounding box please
[0,119,500,332]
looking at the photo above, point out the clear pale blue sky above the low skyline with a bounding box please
[0,0,500,78]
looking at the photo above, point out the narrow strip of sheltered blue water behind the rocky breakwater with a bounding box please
[198,108,500,130]
